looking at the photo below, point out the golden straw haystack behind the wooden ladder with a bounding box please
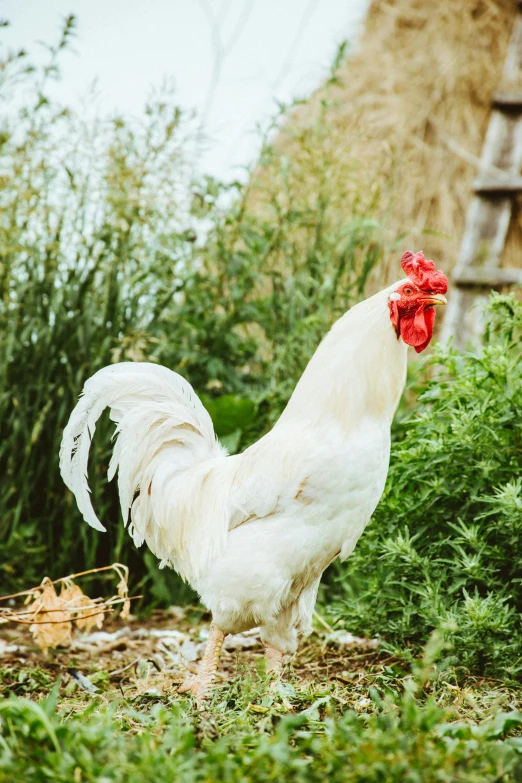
[258,0,512,277]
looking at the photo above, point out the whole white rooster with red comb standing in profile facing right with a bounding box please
[60,253,447,700]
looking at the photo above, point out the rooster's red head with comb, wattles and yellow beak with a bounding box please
[389,251,448,353]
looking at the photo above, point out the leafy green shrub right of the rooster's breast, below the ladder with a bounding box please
[335,295,522,677]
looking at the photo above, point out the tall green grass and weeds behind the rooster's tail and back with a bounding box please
[0,18,381,601]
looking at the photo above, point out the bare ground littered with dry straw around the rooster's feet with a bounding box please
[0,607,522,717]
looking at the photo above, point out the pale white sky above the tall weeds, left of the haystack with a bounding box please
[0,0,370,179]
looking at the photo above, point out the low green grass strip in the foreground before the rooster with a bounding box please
[0,653,522,783]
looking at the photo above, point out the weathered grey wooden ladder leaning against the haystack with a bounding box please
[441,2,522,349]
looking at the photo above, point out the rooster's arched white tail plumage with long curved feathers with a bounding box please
[60,362,231,581]
